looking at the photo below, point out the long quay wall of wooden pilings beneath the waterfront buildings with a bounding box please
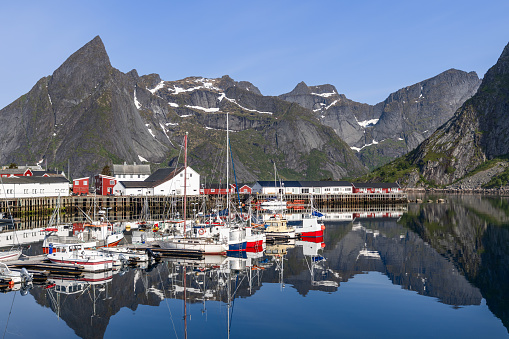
[0,193,408,222]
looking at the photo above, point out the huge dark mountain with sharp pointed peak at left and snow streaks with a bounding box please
[0,36,366,182]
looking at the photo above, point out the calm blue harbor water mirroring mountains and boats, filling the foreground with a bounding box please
[0,196,509,338]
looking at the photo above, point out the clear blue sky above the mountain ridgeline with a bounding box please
[0,0,509,108]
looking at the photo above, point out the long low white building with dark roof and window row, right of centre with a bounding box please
[253,181,353,195]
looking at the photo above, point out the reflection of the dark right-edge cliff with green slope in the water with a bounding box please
[401,196,509,334]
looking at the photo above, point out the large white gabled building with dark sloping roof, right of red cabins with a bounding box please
[113,166,200,195]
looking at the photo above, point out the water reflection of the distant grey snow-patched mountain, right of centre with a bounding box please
[286,218,482,305]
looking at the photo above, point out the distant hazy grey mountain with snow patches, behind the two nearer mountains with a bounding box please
[280,69,480,168]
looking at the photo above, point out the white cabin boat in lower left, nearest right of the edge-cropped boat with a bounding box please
[46,244,114,272]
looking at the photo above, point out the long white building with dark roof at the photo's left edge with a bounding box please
[0,176,70,199]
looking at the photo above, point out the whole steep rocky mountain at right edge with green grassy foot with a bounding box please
[362,44,509,188]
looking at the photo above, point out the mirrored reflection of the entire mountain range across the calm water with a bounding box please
[23,197,509,338]
